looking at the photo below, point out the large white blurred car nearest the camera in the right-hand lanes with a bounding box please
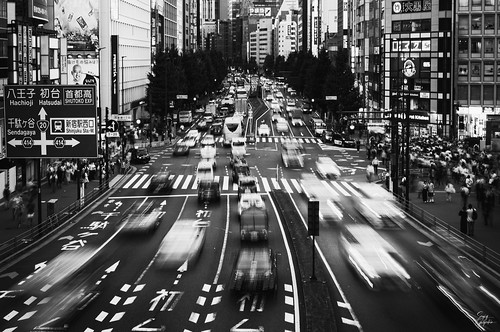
[340,224,411,291]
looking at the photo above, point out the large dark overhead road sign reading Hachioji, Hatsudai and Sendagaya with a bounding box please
[4,85,98,159]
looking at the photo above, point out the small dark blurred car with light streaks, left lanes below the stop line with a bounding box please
[118,202,165,233]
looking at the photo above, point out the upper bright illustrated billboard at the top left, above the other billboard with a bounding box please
[54,0,99,51]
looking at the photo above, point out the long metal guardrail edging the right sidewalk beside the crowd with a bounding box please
[396,196,500,275]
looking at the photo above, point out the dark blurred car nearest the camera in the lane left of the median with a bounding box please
[229,247,278,292]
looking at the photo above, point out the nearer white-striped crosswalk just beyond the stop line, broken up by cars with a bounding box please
[114,174,362,197]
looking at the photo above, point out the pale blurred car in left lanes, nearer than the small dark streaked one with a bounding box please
[155,219,208,270]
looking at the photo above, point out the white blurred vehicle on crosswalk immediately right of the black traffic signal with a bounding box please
[300,173,343,222]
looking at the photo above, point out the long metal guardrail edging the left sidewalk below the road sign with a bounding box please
[0,181,113,264]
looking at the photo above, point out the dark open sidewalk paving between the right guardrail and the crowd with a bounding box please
[410,190,500,253]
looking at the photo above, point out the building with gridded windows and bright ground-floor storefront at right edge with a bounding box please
[454,0,500,139]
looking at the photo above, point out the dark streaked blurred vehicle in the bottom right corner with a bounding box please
[417,246,500,331]
